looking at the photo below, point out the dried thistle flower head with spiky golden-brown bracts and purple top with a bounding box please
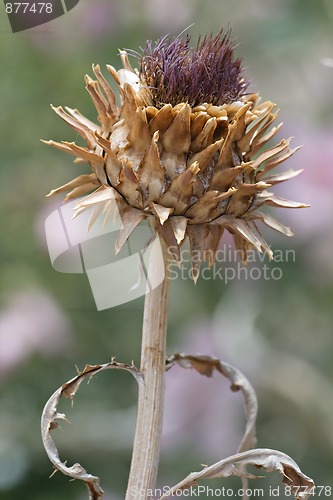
[43,31,306,278]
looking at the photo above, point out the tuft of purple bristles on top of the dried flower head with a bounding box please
[140,30,249,107]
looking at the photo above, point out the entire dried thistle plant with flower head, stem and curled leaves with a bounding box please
[42,31,314,500]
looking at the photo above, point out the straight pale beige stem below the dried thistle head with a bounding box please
[126,238,169,500]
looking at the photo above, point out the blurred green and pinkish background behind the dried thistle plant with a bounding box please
[0,0,333,500]
